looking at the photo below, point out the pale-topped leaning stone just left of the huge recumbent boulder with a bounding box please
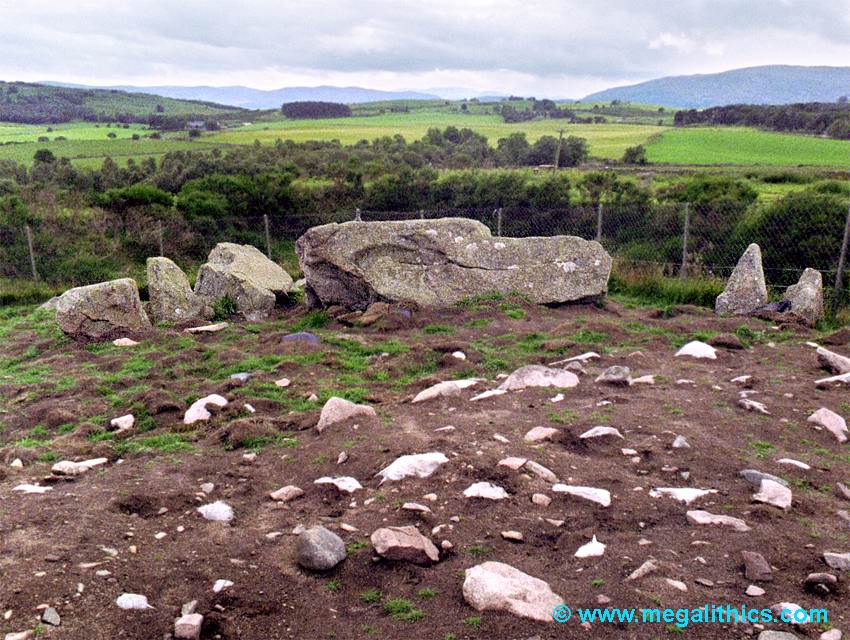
[195,242,292,320]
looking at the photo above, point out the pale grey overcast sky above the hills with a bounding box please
[0,0,850,97]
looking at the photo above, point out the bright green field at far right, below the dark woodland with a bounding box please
[647,127,850,167]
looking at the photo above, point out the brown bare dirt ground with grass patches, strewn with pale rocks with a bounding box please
[0,299,850,640]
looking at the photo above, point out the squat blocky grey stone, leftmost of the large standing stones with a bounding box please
[56,278,151,341]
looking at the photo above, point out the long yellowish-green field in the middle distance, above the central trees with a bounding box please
[203,111,664,158]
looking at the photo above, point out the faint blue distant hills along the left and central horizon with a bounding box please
[41,82,440,109]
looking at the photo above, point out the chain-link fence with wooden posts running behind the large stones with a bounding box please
[0,201,850,302]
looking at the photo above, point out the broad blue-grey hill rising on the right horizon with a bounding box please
[583,65,850,108]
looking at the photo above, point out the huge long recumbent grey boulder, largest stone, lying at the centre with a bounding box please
[295,218,611,309]
